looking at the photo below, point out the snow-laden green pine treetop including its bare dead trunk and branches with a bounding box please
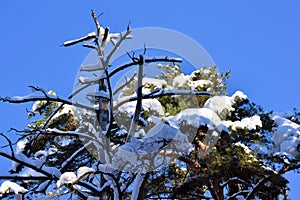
[0,11,300,199]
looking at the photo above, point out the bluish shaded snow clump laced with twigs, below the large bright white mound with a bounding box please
[112,122,193,173]
